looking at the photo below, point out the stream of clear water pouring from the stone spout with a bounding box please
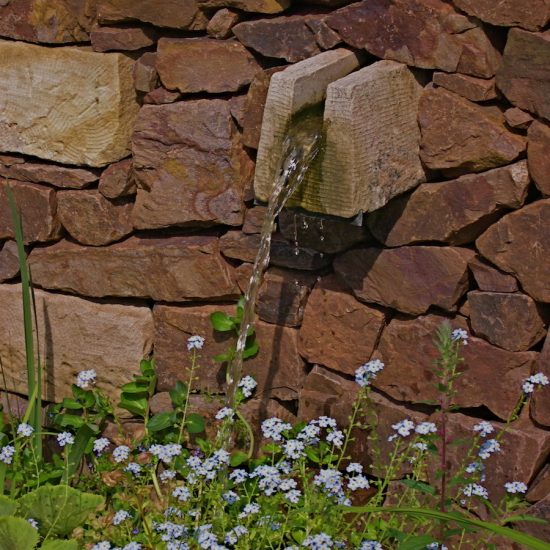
[227,112,322,407]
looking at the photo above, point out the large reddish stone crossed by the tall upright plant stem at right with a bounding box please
[373,315,538,418]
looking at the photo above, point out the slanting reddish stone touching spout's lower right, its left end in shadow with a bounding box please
[368,161,530,246]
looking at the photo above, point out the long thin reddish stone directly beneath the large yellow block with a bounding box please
[0,155,99,189]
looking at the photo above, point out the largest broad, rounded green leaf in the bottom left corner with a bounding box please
[17,485,105,548]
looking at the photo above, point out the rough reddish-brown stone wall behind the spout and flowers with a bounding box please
[0,0,550,512]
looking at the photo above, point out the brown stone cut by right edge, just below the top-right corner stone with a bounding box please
[497,29,550,120]
